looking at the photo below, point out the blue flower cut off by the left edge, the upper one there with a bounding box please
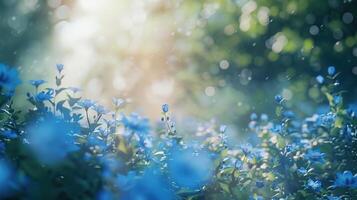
[0,63,21,92]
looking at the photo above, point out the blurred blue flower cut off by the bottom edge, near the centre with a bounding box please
[120,169,176,200]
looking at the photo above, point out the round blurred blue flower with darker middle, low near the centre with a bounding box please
[168,149,213,189]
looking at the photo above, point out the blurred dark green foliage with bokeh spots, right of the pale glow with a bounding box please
[172,0,357,126]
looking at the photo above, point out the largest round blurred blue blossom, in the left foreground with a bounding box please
[27,117,79,164]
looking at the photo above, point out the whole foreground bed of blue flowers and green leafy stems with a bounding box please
[0,64,357,200]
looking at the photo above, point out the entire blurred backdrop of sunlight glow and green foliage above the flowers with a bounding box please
[0,0,357,134]
